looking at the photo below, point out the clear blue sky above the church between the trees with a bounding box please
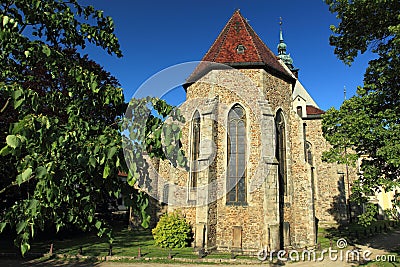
[80,0,371,110]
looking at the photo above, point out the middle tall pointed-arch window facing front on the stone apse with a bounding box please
[226,104,246,205]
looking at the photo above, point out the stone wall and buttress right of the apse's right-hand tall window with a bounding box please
[263,72,315,247]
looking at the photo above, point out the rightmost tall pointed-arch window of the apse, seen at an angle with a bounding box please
[275,110,287,195]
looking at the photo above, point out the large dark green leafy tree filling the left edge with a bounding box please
[0,0,126,254]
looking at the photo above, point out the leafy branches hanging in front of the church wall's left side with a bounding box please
[121,97,187,228]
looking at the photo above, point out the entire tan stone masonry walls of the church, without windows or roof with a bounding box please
[152,66,354,251]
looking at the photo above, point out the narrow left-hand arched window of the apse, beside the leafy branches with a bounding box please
[190,110,200,188]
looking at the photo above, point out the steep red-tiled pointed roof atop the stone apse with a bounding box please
[203,10,292,77]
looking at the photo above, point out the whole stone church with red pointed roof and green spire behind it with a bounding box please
[153,10,356,253]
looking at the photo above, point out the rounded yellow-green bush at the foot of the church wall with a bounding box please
[152,211,192,248]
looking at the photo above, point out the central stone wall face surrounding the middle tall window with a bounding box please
[203,70,265,250]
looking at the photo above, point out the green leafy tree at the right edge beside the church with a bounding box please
[323,0,400,214]
